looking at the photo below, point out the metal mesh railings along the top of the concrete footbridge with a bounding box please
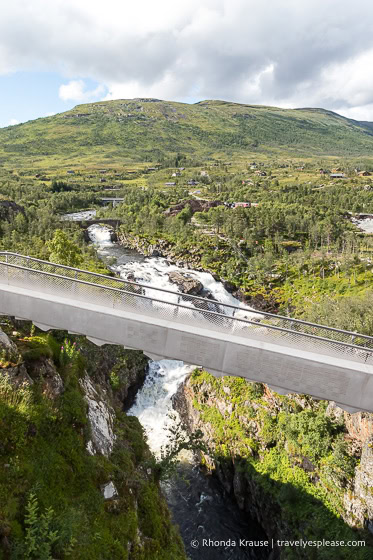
[0,252,373,364]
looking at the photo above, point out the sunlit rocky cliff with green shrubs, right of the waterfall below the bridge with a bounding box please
[174,370,373,560]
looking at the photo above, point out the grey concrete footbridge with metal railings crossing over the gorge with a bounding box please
[0,252,373,412]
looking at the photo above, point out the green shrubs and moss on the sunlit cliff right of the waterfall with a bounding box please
[189,370,372,560]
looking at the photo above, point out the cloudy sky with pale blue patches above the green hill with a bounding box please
[0,0,373,127]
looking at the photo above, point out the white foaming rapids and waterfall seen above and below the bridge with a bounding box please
[88,225,258,455]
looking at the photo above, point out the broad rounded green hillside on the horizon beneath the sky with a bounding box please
[0,99,373,168]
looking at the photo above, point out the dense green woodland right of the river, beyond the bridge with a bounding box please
[101,179,373,318]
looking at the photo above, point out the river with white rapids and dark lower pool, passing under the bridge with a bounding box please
[88,225,269,560]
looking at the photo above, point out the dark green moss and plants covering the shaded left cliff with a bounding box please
[0,326,184,560]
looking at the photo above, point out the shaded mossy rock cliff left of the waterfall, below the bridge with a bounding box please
[0,317,185,560]
